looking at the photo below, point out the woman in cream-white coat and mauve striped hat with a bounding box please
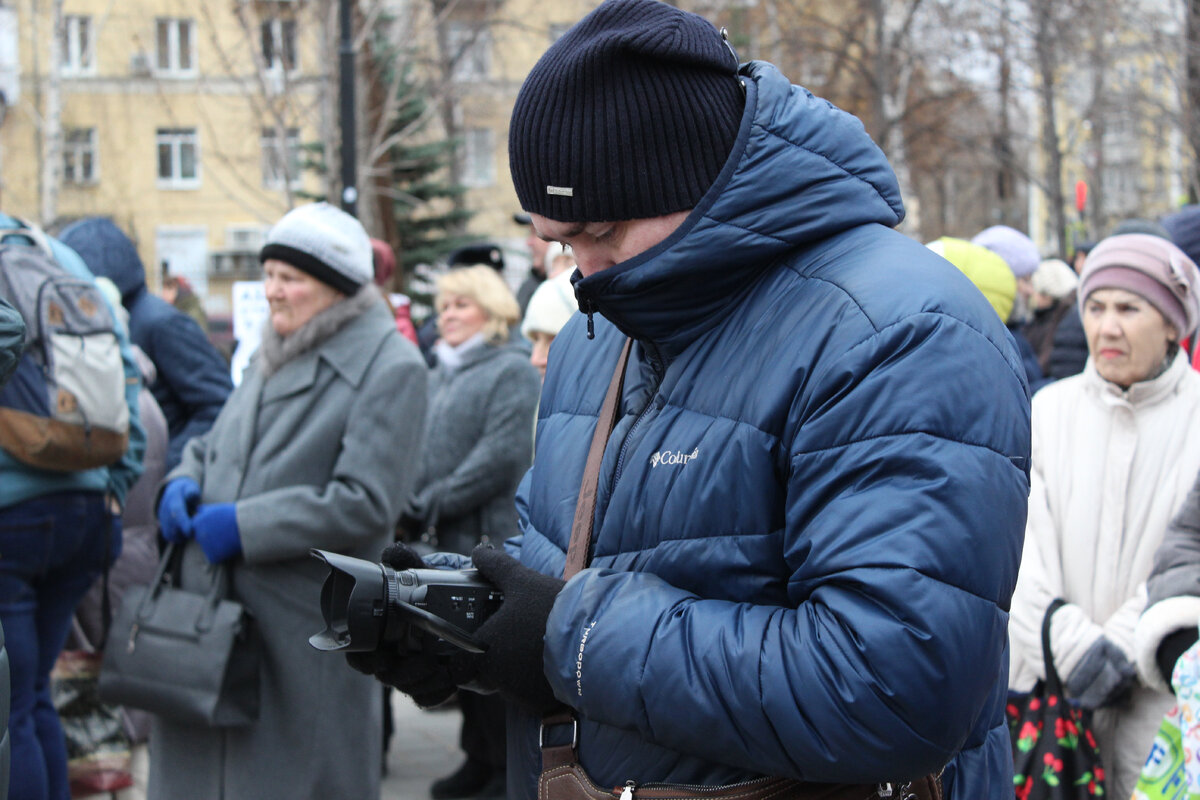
[1009,234,1200,798]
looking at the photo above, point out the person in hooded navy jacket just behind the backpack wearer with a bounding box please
[59,217,233,471]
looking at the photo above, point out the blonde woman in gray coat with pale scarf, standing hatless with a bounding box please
[404,266,541,800]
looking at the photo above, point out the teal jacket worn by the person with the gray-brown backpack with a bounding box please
[0,213,146,509]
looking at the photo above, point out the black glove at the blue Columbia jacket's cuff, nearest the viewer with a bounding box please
[452,545,565,714]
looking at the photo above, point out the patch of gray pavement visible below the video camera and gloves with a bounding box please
[382,692,463,800]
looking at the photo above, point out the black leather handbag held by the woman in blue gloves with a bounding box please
[98,543,262,727]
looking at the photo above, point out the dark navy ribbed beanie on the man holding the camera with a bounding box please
[509,0,744,222]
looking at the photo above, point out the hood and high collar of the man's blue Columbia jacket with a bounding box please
[574,61,904,359]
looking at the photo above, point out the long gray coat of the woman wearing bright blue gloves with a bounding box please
[149,299,426,800]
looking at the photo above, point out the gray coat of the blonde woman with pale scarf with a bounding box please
[409,345,541,554]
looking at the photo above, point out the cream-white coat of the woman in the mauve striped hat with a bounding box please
[1009,354,1200,798]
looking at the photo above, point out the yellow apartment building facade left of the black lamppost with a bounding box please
[0,0,336,313]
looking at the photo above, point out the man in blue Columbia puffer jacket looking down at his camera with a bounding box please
[350,0,1030,800]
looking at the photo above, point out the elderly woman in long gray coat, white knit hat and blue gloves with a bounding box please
[149,203,426,800]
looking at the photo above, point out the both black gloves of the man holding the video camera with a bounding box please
[346,543,564,714]
